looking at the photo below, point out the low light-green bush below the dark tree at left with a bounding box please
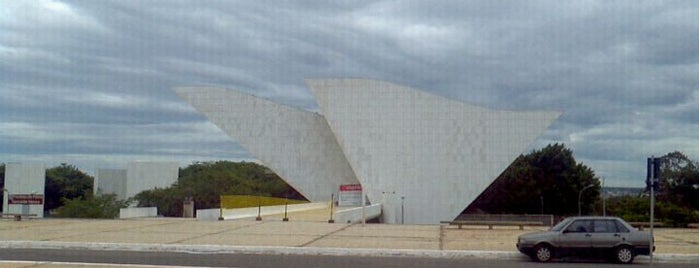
[56,194,131,219]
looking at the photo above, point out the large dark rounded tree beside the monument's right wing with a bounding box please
[465,143,600,215]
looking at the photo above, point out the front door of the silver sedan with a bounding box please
[558,219,592,255]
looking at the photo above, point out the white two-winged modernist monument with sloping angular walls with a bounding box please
[175,79,560,224]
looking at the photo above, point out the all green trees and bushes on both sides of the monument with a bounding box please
[0,143,699,226]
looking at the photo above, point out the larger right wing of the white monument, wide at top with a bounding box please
[307,79,560,223]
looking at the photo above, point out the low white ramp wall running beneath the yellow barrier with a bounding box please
[197,202,329,221]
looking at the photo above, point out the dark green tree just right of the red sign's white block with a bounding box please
[44,163,94,211]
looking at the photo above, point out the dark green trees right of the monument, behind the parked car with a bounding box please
[464,144,699,226]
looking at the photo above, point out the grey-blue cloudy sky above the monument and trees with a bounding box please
[0,0,699,186]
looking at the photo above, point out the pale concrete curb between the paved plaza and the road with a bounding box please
[0,241,699,263]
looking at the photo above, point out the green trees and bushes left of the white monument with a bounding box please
[0,161,303,218]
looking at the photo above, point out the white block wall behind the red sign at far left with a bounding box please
[3,163,46,218]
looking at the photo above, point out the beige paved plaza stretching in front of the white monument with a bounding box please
[0,214,699,263]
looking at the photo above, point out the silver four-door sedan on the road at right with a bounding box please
[517,216,655,263]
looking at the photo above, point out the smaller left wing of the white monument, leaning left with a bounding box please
[175,88,359,201]
